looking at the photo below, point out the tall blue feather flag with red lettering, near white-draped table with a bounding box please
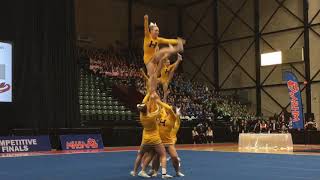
[284,71,304,129]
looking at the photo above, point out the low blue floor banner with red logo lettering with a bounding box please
[60,134,104,150]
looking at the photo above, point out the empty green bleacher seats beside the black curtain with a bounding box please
[79,69,135,124]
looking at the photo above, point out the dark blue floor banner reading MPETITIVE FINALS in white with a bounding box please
[0,136,51,153]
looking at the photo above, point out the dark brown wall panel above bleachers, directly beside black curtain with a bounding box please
[75,0,129,48]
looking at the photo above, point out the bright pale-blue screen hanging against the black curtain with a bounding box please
[0,42,12,102]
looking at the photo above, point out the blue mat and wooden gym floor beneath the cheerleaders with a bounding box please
[0,144,320,180]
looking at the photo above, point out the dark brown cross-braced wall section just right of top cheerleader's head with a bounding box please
[182,0,214,87]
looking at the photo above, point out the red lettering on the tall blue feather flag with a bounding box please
[287,80,300,122]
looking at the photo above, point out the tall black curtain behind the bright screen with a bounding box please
[0,0,79,133]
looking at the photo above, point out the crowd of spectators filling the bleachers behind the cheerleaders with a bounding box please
[80,45,302,132]
